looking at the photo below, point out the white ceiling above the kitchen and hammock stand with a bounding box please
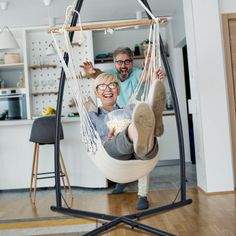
[0,0,182,28]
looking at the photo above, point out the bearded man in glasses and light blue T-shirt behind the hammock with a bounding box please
[81,47,164,210]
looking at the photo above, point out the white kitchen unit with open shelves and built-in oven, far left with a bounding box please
[0,29,29,121]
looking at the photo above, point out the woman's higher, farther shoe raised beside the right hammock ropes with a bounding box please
[148,79,166,137]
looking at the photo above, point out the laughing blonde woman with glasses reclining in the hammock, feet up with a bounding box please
[89,73,165,160]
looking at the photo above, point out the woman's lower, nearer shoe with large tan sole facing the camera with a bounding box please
[132,103,155,159]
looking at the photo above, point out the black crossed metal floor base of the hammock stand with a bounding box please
[51,199,192,235]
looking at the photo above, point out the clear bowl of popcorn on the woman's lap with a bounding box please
[105,109,131,135]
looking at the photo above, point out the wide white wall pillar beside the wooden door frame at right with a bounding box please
[183,0,234,192]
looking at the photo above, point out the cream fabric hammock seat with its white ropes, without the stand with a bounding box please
[51,0,161,183]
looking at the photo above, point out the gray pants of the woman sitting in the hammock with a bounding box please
[103,128,158,161]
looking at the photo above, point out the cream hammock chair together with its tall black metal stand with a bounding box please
[49,0,192,236]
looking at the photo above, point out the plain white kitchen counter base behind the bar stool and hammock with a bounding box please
[0,111,183,190]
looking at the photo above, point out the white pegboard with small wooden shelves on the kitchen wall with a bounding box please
[27,29,96,117]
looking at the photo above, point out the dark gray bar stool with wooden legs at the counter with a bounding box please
[29,116,72,203]
